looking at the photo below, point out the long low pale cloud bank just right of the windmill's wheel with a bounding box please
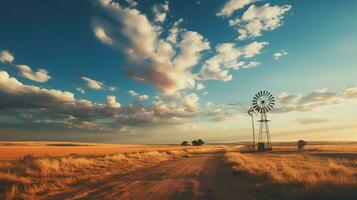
[273,86,357,113]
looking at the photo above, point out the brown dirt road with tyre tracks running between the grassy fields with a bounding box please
[43,152,255,200]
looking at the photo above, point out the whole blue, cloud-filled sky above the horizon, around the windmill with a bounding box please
[0,0,357,144]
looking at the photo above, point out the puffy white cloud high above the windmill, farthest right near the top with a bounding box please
[229,3,291,40]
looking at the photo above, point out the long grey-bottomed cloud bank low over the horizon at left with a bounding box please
[0,71,198,132]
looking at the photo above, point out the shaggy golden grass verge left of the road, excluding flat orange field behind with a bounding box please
[0,146,223,199]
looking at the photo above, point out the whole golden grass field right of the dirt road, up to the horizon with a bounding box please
[225,144,357,199]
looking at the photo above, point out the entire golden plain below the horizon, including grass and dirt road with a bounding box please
[0,142,357,199]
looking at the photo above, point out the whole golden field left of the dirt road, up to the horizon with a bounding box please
[0,143,225,199]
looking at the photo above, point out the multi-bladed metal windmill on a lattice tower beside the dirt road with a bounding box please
[252,91,275,152]
